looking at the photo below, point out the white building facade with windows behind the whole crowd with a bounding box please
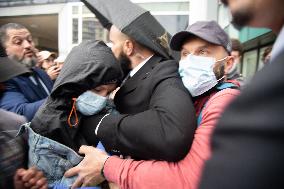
[0,0,275,79]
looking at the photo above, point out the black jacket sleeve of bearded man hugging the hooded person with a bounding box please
[84,58,196,161]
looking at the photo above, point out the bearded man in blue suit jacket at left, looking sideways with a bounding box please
[0,23,53,121]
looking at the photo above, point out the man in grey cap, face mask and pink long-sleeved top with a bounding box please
[67,21,239,189]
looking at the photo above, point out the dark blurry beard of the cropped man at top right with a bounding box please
[232,9,253,30]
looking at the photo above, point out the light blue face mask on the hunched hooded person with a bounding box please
[76,91,107,116]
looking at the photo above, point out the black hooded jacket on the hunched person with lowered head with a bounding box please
[31,40,122,150]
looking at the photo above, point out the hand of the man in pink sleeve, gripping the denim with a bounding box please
[64,145,108,189]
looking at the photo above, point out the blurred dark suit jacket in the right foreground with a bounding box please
[200,49,284,189]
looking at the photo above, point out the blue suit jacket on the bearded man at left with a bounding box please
[0,68,53,121]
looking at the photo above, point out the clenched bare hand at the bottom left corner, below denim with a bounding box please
[14,167,47,189]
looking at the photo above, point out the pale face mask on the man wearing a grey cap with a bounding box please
[179,54,227,96]
